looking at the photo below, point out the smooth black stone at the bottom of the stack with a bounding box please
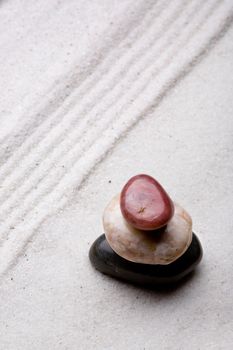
[89,233,202,286]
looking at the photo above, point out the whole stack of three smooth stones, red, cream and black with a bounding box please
[89,174,202,285]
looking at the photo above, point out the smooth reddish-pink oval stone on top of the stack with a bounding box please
[120,174,174,231]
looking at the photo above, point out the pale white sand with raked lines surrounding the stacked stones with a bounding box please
[0,1,233,350]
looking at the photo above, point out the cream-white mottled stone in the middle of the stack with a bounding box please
[103,194,192,265]
